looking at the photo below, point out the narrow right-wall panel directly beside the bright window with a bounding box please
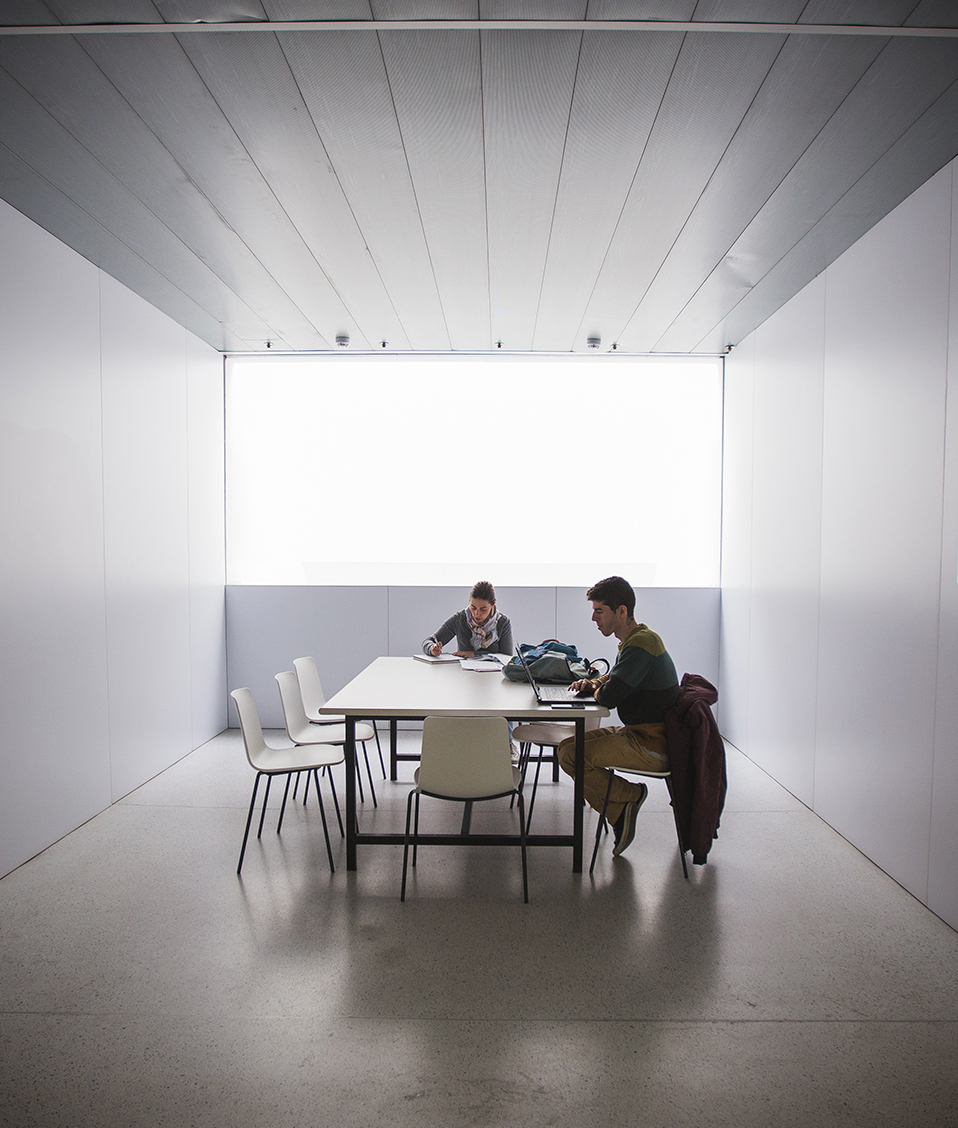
[717,335,755,751]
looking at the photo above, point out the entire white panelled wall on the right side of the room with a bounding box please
[720,166,958,926]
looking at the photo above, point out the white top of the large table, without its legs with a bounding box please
[319,658,608,721]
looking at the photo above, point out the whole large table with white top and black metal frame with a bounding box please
[319,658,608,873]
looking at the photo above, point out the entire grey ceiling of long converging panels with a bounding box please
[0,0,958,352]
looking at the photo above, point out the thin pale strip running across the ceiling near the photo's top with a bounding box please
[0,19,958,39]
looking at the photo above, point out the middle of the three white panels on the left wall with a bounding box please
[102,275,193,799]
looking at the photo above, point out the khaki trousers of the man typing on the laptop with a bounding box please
[559,724,669,823]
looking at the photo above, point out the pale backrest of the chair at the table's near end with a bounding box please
[419,716,516,799]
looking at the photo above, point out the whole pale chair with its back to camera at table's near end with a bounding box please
[399,716,529,904]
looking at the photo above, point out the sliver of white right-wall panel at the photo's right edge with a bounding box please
[928,165,958,928]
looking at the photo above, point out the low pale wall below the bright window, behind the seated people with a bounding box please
[227,578,719,728]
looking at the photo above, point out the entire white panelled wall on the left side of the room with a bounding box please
[0,203,227,874]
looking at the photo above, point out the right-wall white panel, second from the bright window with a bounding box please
[748,275,825,805]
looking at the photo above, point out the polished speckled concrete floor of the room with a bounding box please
[0,731,958,1128]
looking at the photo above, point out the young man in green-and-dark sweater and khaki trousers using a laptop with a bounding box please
[559,575,679,856]
